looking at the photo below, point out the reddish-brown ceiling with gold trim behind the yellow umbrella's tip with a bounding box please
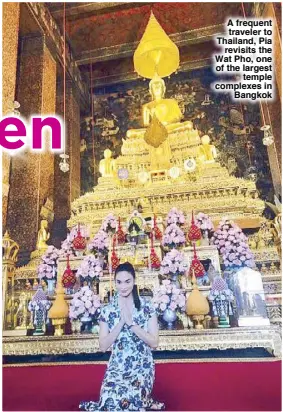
[43,2,242,87]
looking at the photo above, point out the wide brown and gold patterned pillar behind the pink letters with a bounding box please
[7,37,56,257]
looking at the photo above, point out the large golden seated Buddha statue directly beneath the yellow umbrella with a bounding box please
[127,74,192,170]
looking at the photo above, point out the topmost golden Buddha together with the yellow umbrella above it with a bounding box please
[122,13,199,173]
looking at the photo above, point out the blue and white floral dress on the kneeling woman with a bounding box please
[80,294,164,411]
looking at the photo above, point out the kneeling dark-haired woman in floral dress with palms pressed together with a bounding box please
[80,262,164,411]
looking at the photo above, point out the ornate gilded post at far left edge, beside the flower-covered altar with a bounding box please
[2,232,19,329]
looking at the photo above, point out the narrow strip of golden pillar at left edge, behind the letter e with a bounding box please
[2,3,20,228]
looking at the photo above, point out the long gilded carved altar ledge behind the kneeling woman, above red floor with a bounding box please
[3,326,282,358]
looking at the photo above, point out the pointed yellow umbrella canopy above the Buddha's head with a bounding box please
[134,12,180,79]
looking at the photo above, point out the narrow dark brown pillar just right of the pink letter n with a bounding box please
[52,80,81,247]
